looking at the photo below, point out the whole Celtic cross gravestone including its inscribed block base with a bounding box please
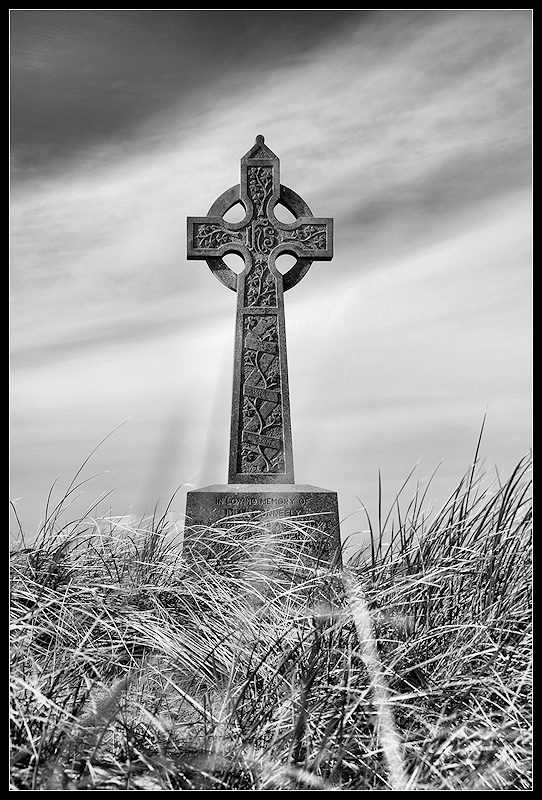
[185,136,341,565]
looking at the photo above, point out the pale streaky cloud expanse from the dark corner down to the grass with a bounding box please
[12,10,530,536]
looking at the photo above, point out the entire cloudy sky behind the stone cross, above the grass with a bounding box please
[10,9,532,544]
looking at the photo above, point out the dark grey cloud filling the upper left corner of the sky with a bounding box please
[10,9,367,173]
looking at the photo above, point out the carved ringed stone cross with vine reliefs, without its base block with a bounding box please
[187,136,333,484]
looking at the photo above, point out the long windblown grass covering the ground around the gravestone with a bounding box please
[11,458,531,791]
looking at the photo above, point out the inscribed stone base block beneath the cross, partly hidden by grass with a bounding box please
[184,483,341,567]
